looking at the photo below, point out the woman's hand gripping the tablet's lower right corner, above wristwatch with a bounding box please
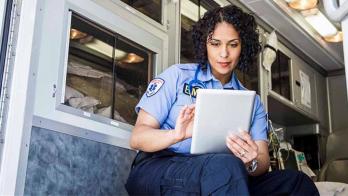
[226,131,259,165]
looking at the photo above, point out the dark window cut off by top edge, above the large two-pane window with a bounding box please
[121,0,162,24]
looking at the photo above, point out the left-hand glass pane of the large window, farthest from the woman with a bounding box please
[65,16,114,118]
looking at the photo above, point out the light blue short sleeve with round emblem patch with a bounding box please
[135,65,179,125]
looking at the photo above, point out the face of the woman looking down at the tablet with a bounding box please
[207,22,242,84]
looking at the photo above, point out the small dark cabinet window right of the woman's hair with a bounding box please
[271,50,291,100]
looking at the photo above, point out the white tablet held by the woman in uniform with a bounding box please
[190,89,256,154]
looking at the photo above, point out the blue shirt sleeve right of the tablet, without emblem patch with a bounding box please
[250,95,268,141]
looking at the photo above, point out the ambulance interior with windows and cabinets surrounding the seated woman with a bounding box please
[0,0,348,195]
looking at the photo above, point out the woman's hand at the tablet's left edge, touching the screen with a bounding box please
[173,105,195,142]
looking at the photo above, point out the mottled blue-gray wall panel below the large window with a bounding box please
[24,127,135,195]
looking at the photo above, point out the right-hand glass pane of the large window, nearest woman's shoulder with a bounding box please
[114,37,152,124]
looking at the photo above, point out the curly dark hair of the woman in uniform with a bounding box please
[192,5,261,71]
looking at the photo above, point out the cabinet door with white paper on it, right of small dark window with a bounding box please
[292,61,318,118]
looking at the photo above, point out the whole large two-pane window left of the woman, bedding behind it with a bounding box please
[64,13,154,124]
